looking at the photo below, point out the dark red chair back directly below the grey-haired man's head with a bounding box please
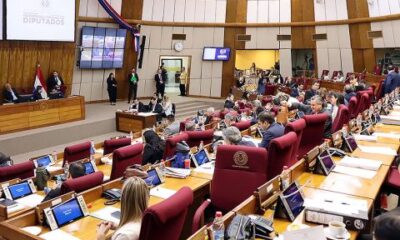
[297,113,329,158]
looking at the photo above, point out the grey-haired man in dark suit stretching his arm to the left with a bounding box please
[282,95,332,138]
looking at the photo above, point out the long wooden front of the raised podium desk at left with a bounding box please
[0,96,85,134]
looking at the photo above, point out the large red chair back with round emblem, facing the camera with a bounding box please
[211,145,268,211]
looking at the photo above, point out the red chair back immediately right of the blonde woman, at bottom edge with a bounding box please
[139,187,193,240]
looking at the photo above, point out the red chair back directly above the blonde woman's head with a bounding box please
[110,143,143,180]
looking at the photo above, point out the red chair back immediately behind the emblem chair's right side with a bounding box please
[267,132,297,180]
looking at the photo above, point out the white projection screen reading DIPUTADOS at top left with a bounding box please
[6,0,75,42]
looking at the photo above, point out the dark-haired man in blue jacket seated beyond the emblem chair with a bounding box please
[258,112,285,148]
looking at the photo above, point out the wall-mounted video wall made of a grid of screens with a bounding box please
[79,27,127,69]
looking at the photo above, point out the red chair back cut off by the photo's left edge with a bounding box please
[0,161,35,182]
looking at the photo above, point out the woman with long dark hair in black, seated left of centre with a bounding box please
[142,130,165,165]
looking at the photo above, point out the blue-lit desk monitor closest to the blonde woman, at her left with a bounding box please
[53,198,84,227]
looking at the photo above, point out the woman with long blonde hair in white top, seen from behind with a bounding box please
[97,177,150,240]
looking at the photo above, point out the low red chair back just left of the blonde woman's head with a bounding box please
[61,171,104,194]
